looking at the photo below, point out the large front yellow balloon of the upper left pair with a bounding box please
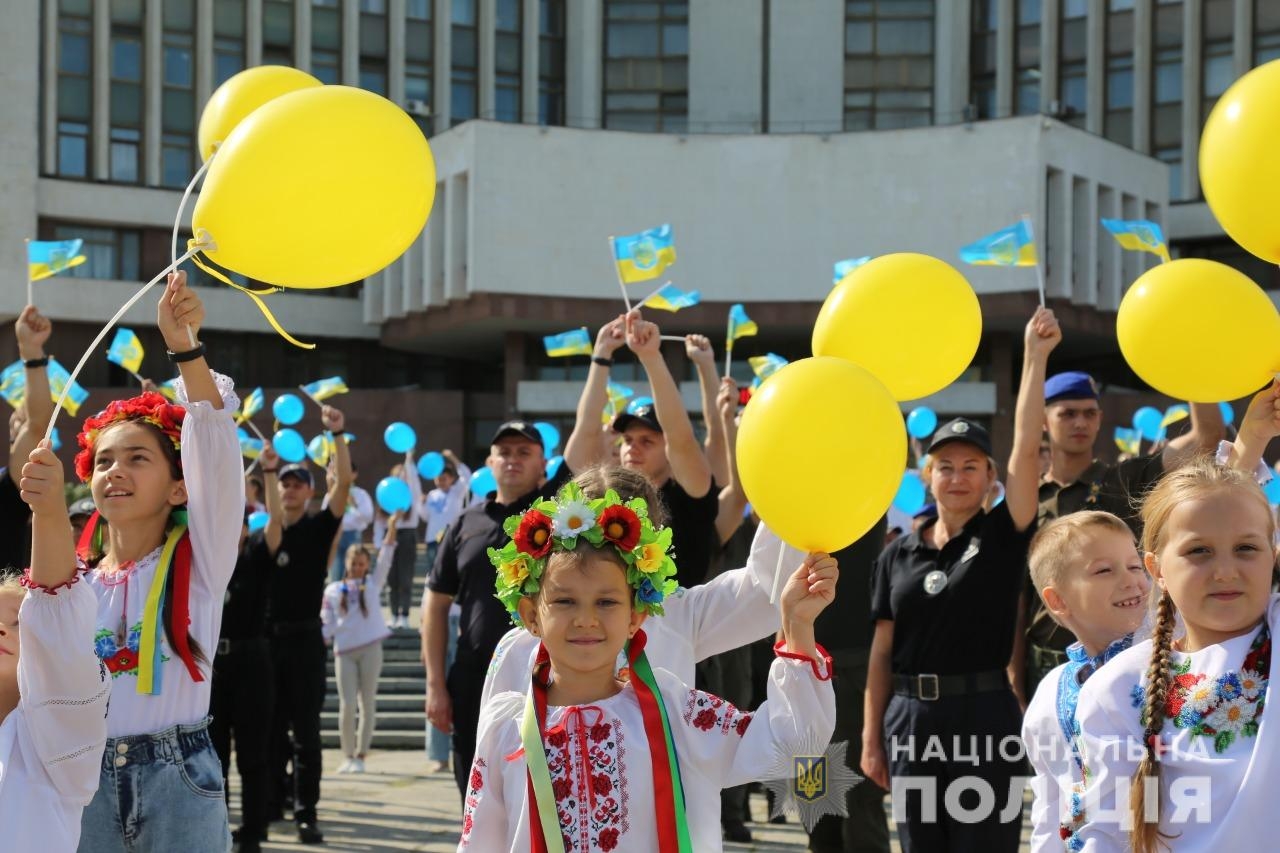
[192,86,435,288]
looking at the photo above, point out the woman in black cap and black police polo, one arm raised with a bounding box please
[861,307,1062,853]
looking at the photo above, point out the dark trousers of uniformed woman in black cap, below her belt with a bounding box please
[885,690,1027,853]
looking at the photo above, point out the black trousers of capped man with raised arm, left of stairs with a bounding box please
[271,620,326,824]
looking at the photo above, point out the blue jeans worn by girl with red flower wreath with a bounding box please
[78,720,232,853]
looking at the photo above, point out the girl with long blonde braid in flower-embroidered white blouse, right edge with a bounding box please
[1078,384,1280,853]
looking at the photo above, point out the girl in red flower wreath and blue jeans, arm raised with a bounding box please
[67,273,244,853]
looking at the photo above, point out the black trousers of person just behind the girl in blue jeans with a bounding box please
[209,638,275,835]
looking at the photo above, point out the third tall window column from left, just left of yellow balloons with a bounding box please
[160,0,196,188]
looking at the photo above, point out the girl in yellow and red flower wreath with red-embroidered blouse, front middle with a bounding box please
[458,483,838,853]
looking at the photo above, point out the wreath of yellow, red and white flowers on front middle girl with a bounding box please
[489,483,676,625]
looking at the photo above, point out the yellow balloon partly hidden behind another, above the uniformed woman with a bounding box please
[813,252,982,399]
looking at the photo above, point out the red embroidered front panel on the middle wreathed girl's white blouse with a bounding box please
[545,704,631,853]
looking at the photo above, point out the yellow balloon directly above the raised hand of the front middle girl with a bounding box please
[737,356,906,552]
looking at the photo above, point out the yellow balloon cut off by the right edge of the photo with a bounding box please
[1199,60,1280,264]
